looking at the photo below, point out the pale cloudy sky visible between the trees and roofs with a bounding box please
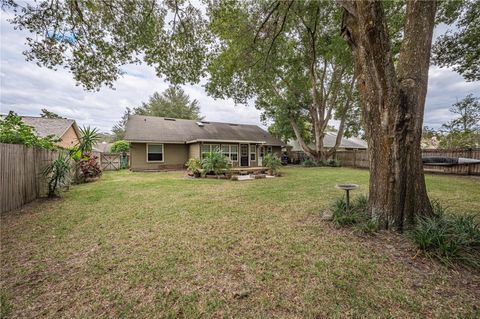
[0,11,480,132]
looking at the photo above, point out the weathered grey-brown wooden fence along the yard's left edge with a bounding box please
[0,143,57,213]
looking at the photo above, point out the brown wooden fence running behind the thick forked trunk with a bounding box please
[335,149,480,175]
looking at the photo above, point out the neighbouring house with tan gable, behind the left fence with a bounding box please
[22,116,80,148]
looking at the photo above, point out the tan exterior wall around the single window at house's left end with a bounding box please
[130,143,189,171]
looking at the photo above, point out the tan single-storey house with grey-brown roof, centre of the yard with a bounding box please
[125,115,285,171]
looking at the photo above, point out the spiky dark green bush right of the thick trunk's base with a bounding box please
[411,202,480,267]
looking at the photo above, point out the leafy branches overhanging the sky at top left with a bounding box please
[2,0,209,90]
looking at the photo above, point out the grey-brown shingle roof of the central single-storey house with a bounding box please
[125,115,285,146]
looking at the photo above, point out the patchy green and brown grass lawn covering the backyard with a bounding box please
[1,168,480,318]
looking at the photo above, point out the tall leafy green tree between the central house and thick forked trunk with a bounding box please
[207,1,360,160]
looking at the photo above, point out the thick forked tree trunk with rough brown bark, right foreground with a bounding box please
[339,0,435,231]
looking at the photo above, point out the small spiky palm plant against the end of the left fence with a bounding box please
[42,151,70,197]
